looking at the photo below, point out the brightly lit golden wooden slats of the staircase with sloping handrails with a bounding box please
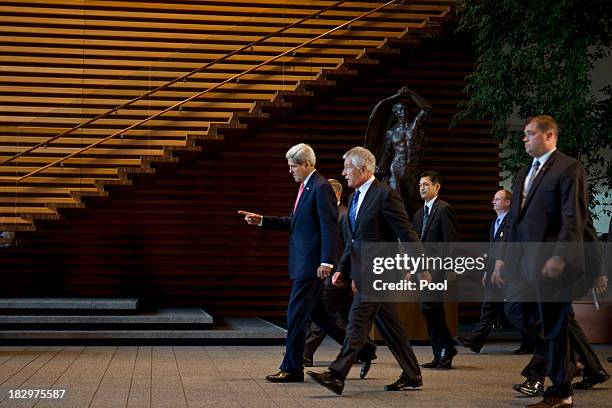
[0,0,452,231]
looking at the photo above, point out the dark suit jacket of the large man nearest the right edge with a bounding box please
[504,150,588,282]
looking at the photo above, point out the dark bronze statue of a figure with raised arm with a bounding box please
[365,86,431,216]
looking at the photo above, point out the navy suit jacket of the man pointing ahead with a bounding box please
[262,172,338,280]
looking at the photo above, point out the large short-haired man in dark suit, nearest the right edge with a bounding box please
[492,115,588,408]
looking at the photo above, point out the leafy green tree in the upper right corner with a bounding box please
[455,0,612,217]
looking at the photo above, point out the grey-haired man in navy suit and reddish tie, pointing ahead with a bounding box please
[239,143,372,382]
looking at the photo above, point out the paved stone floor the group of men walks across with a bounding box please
[0,341,612,408]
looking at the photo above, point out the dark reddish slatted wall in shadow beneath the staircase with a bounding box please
[0,30,499,316]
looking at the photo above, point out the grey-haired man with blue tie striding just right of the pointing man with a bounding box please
[308,147,431,394]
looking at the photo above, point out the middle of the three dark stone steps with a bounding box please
[0,307,213,325]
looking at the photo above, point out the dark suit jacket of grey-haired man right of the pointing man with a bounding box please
[338,179,422,281]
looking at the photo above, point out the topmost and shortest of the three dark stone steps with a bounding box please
[0,298,138,311]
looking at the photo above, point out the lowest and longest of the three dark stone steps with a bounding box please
[0,318,287,342]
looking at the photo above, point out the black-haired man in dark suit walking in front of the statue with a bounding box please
[413,171,457,369]
